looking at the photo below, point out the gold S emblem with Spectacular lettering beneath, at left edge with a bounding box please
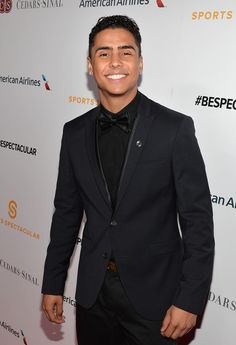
[0,200,40,240]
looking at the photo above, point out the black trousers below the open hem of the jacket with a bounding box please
[76,271,176,345]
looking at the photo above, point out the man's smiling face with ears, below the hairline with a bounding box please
[88,28,143,97]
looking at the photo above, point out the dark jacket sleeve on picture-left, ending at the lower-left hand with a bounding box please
[42,125,83,295]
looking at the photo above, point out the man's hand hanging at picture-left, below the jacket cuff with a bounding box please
[42,295,65,324]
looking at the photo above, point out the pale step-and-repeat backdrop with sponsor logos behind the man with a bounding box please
[0,0,236,345]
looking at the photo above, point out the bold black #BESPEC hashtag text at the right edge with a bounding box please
[195,96,236,110]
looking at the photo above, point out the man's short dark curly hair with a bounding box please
[89,15,142,57]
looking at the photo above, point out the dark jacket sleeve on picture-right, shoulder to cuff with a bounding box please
[173,117,214,314]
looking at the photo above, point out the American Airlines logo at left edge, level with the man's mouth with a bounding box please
[0,74,51,91]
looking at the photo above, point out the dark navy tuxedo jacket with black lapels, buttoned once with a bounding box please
[42,94,214,320]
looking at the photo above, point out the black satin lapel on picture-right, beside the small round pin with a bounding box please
[115,95,153,213]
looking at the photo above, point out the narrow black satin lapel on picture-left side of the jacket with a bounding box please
[86,108,112,209]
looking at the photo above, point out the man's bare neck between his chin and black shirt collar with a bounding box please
[100,89,138,114]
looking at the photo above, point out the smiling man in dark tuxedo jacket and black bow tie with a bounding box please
[42,16,214,345]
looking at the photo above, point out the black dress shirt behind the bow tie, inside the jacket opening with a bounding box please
[97,92,140,209]
